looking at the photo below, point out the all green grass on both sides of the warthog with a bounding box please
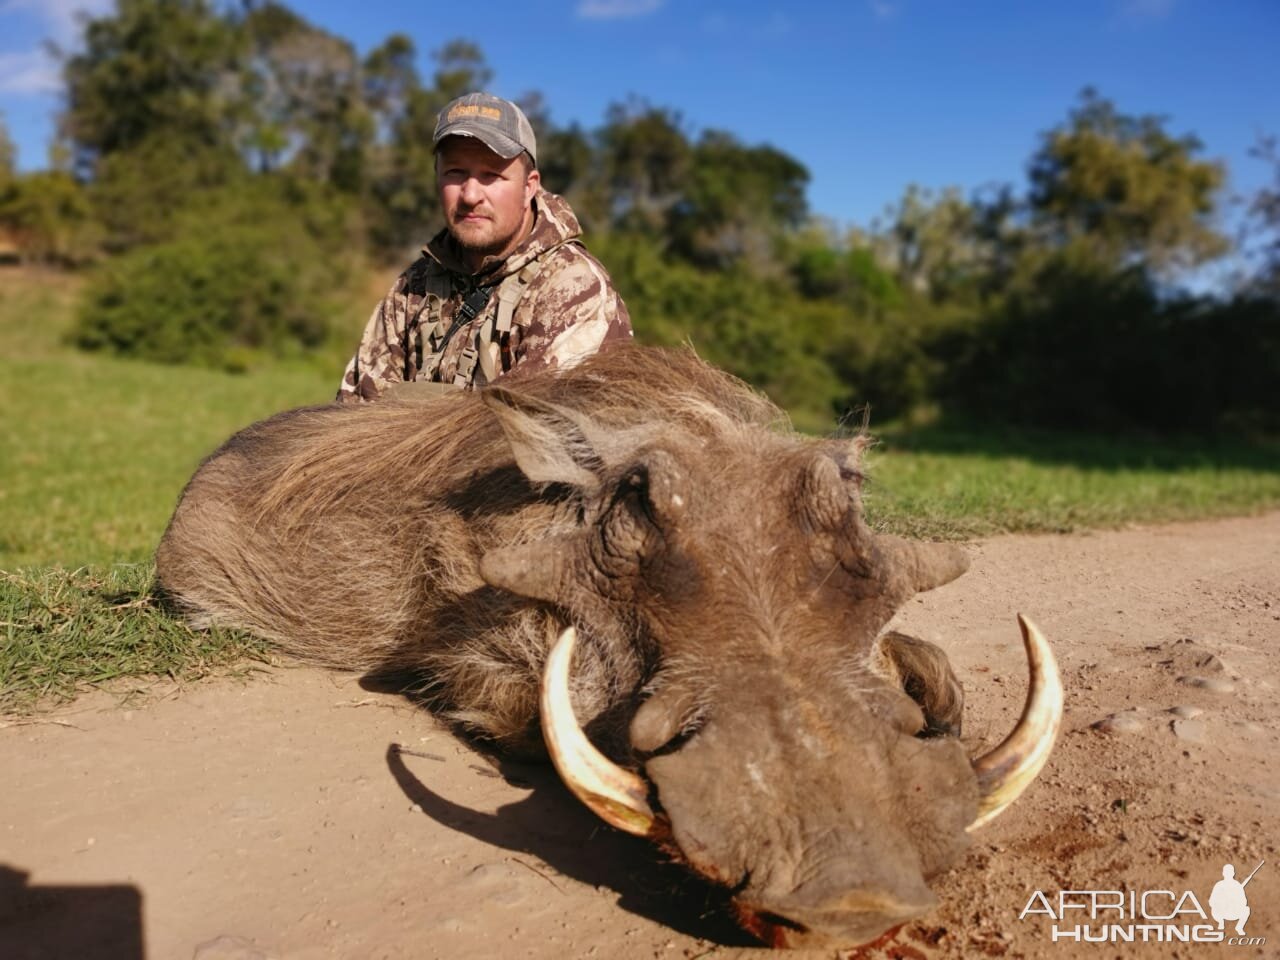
[0,268,1280,710]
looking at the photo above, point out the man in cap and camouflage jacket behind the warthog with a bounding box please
[338,93,631,402]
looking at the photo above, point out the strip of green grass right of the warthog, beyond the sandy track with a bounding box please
[865,426,1280,539]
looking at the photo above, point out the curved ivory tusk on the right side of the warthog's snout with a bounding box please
[968,613,1062,831]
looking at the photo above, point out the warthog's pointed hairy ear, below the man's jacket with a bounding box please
[480,387,604,490]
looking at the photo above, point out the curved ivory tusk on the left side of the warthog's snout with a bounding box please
[539,627,658,837]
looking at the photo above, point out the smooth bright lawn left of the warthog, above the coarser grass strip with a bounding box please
[0,270,340,570]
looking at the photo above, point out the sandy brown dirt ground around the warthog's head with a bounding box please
[0,513,1280,960]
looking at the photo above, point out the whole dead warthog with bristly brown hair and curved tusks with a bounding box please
[156,348,1061,946]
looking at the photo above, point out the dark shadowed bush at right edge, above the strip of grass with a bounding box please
[940,250,1280,434]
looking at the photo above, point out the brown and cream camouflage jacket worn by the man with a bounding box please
[338,191,631,402]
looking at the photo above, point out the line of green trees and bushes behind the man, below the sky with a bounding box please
[0,0,1280,433]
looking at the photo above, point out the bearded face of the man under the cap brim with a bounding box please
[435,137,539,266]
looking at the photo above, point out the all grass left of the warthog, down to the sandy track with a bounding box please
[0,269,330,713]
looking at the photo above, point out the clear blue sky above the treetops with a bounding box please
[0,0,1280,231]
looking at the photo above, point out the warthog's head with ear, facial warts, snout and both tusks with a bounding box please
[480,388,1061,946]
